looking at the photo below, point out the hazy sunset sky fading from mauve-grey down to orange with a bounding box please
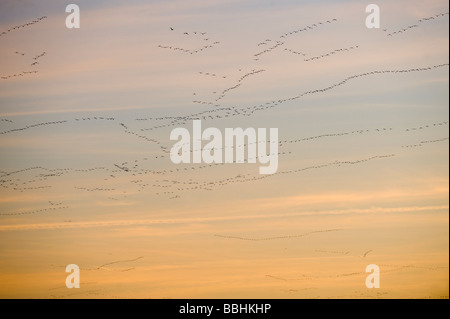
[0,0,449,299]
